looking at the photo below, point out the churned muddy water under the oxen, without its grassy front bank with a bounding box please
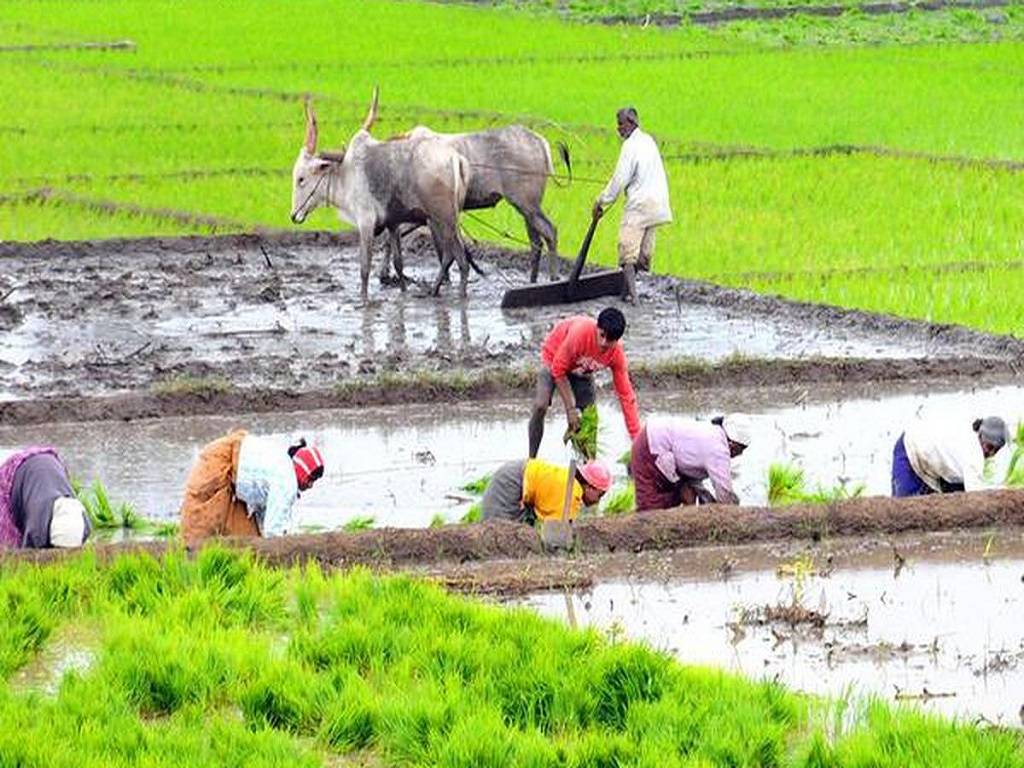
[0,242,991,399]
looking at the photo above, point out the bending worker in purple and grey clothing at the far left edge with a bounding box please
[0,445,90,549]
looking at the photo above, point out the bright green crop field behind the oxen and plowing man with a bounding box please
[0,0,1024,334]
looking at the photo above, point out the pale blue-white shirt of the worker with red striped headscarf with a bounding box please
[234,435,299,537]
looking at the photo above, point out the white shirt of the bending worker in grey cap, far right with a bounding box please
[903,420,992,490]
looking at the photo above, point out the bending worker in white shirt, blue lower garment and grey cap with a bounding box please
[892,416,1010,497]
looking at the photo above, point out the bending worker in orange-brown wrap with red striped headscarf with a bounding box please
[181,429,324,546]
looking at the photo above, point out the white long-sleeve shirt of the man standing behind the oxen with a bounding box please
[598,128,672,227]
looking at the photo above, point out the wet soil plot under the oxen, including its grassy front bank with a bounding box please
[0,232,1024,423]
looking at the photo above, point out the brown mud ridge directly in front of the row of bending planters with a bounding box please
[14,490,1024,591]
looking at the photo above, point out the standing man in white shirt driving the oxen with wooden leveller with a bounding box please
[593,106,672,303]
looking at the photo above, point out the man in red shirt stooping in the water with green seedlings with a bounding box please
[529,307,640,459]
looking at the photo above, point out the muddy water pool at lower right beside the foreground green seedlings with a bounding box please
[525,534,1024,727]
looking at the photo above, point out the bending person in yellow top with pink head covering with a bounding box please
[480,459,611,524]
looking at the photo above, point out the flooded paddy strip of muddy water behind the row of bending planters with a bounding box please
[0,387,1024,529]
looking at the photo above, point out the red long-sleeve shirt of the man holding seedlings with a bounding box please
[541,315,640,439]
